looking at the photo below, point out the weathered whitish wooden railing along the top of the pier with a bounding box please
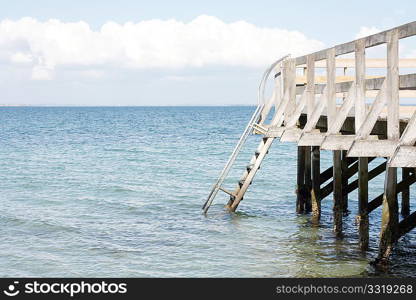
[261,22,416,162]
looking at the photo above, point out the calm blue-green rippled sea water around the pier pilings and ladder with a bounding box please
[0,107,416,277]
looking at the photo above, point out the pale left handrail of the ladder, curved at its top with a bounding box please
[202,55,289,214]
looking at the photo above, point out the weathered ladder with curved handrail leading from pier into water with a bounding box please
[202,55,289,214]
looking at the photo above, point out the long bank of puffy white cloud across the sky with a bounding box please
[0,15,323,79]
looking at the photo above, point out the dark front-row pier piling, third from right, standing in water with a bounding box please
[333,150,343,236]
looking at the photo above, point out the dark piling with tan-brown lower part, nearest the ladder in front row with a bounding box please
[311,146,321,222]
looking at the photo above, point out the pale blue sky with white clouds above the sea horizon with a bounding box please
[0,0,416,106]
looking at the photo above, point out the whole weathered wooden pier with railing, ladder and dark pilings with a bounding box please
[204,22,416,264]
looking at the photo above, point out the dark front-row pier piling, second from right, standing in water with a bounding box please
[357,157,369,251]
